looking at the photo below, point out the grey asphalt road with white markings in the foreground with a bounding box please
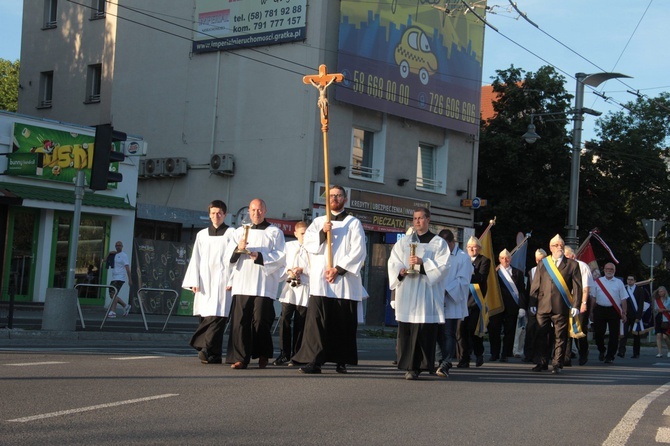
[0,332,670,445]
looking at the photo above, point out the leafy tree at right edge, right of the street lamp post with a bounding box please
[579,93,670,277]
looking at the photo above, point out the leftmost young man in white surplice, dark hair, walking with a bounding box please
[182,200,235,364]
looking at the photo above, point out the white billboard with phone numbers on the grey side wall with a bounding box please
[193,0,307,53]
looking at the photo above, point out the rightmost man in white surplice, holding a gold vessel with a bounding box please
[388,208,450,380]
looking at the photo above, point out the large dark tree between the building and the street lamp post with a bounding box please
[475,66,571,264]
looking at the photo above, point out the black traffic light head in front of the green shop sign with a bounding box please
[89,124,127,190]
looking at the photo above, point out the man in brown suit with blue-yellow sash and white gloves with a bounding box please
[530,234,587,374]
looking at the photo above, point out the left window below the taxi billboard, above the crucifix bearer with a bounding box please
[349,128,385,182]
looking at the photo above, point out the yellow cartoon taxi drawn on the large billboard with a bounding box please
[395,26,437,85]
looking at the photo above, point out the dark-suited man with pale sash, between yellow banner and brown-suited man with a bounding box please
[489,249,525,362]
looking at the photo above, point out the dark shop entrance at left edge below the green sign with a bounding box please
[2,207,40,302]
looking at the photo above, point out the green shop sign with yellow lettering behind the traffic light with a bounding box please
[5,123,121,189]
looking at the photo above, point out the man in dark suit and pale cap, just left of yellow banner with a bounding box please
[456,237,491,368]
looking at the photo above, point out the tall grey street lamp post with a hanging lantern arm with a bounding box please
[522,73,630,249]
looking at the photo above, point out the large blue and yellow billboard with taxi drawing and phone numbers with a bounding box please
[335,0,486,134]
